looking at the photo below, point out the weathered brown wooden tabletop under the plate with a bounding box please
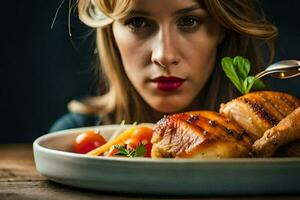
[0,144,300,200]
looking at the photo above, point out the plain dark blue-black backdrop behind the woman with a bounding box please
[0,0,300,143]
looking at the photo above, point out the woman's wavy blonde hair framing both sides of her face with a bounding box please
[69,0,278,123]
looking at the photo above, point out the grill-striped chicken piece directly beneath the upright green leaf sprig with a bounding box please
[220,91,300,141]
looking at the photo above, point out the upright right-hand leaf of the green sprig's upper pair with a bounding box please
[233,56,251,80]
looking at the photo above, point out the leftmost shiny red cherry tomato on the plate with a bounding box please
[73,131,106,154]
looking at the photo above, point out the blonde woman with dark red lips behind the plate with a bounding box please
[52,0,277,131]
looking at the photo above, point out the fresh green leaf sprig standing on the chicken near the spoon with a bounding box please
[221,56,266,94]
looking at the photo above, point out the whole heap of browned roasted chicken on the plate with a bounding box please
[151,91,300,159]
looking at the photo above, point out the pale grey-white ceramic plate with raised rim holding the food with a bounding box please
[33,125,300,195]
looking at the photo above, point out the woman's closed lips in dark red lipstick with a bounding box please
[154,76,185,91]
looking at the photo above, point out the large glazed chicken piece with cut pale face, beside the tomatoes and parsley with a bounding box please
[151,111,252,159]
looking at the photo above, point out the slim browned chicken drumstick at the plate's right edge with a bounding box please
[253,107,300,157]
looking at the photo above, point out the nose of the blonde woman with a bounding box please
[151,29,180,68]
